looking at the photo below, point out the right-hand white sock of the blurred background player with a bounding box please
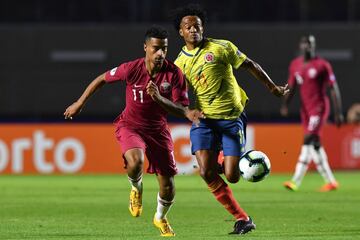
[311,147,335,183]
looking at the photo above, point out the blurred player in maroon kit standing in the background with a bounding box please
[280,35,344,192]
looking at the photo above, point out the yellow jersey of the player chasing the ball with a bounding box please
[175,38,248,120]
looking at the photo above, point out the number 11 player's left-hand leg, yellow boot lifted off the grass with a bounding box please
[116,127,145,217]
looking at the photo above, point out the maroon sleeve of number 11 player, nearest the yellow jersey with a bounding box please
[172,68,189,106]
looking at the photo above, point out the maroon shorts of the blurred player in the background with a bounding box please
[301,105,329,136]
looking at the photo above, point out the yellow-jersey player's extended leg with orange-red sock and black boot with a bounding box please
[190,120,255,234]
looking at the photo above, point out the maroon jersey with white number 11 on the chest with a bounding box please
[105,58,189,132]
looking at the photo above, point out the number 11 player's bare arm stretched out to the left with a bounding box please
[64,73,105,119]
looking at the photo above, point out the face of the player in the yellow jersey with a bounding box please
[179,16,204,45]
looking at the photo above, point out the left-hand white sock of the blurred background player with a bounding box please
[292,145,311,187]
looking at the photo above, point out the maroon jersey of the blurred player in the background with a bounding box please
[288,57,336,113]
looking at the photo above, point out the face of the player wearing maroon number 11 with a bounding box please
[144,38,168,67]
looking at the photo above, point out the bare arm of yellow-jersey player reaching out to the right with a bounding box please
[240,58,289,97]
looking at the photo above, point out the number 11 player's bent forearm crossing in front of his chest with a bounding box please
[146,81,205,124]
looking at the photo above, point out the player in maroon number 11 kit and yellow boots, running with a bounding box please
[64,27,202,236]
